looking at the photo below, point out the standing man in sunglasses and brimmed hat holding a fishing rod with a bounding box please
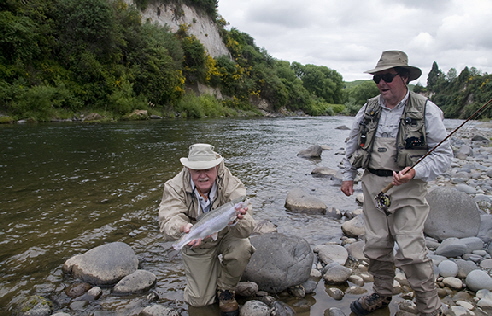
[341,51,453,316]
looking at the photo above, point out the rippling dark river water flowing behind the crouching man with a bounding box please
[0,117,470,315]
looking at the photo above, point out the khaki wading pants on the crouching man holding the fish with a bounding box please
[182,234,254,306]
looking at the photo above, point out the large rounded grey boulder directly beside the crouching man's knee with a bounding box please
[242,233,314,292]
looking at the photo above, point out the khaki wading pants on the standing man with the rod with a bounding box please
[362,171,441,315]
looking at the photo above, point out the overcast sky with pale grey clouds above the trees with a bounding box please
[218,0,492,86]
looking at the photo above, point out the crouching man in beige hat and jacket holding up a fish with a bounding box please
[159,144,254,316]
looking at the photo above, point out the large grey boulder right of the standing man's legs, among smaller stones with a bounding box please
[424,187,481,240]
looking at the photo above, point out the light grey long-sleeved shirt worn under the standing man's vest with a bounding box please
[342,91,453,181]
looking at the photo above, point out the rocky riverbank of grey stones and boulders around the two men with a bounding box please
[9,124,492,316]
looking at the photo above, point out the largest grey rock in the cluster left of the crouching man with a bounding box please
[63,242,138,285]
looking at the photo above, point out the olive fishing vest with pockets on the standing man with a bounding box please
[349,92,428,169]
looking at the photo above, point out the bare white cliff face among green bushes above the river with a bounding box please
[129,0,231,58]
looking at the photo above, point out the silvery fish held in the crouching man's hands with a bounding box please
[173,196,248,250]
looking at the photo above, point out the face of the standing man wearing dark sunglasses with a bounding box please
[374,68,407,106]
